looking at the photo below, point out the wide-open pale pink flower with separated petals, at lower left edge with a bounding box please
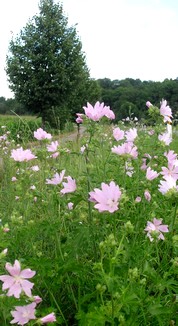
[0,260,36,298]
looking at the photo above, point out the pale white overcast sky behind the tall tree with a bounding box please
[0,0,178,98]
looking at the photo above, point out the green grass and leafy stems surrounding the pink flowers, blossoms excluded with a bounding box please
[0,116,178,326]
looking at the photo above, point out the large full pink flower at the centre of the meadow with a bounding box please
[89,181,121,213]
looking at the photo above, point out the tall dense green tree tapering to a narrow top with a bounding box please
[6,0,97,127]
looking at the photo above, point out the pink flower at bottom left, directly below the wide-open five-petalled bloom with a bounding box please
[10,302,36,326]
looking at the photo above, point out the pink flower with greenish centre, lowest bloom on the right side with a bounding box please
[144,218,169,241]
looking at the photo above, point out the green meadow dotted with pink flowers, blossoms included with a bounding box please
[0,105,178,326]
